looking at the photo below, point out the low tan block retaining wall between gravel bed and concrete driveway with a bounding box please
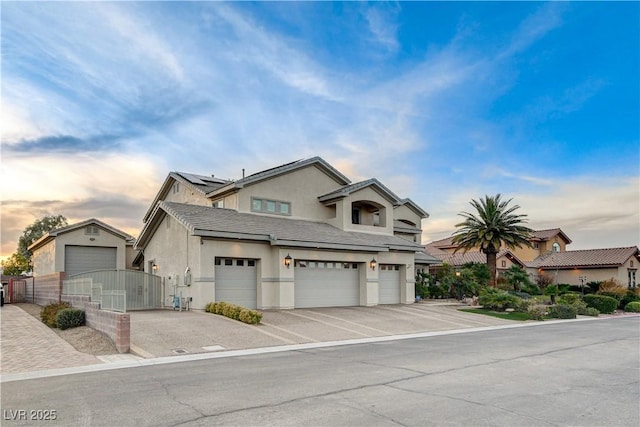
[62,295,131,353]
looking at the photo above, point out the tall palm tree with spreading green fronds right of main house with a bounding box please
[452,194,533,286]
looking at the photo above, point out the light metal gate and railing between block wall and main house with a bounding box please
[62,270,162,312]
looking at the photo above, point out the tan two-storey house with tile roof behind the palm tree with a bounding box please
[426,228,571,267]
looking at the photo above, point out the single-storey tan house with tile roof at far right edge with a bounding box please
[527,246,640,288]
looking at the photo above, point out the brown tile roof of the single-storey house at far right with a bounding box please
[527,246,640,270]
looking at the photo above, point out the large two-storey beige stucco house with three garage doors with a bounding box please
[136,157,428,309]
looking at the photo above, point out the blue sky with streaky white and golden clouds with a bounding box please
[0,1,640,257]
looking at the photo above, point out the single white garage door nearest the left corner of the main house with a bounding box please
[215,258,258,308]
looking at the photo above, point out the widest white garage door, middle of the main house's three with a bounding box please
[294,261,360,308]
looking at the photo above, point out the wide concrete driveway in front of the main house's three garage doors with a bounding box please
[130,302,514,358]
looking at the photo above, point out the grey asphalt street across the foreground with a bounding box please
[2,317,640,426]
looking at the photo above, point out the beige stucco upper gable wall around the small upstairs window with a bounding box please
[235,166,340,221]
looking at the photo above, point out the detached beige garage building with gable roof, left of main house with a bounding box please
[29,218,135,277]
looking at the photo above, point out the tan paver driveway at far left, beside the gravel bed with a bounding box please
[0,304,103,374]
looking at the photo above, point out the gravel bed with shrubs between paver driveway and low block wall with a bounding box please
[16,303,118,356]
